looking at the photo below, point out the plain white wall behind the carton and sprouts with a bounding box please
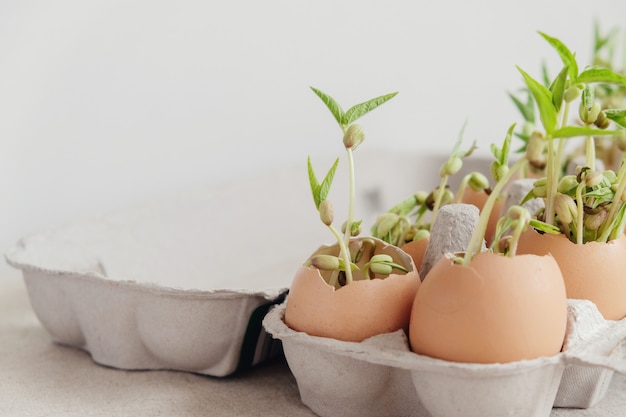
[0,0,626,275]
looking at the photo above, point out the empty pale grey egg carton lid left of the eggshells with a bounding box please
[5,150,445,376]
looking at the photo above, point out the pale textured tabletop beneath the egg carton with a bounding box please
[0,276,626,417]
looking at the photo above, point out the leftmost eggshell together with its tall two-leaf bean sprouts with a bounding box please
[285,88,420,342]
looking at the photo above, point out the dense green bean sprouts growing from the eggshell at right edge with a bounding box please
[518,33,626,244]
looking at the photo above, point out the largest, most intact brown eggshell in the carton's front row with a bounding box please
[409,252,567,363]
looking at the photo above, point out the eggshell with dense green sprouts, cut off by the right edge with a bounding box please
[510,34,626,320]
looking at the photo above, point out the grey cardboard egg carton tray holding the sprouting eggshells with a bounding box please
[263,300,626,417]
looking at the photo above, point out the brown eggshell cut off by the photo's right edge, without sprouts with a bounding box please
[517,230,626,320]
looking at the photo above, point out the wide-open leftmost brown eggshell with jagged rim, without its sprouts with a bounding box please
[285,237,420,342]
